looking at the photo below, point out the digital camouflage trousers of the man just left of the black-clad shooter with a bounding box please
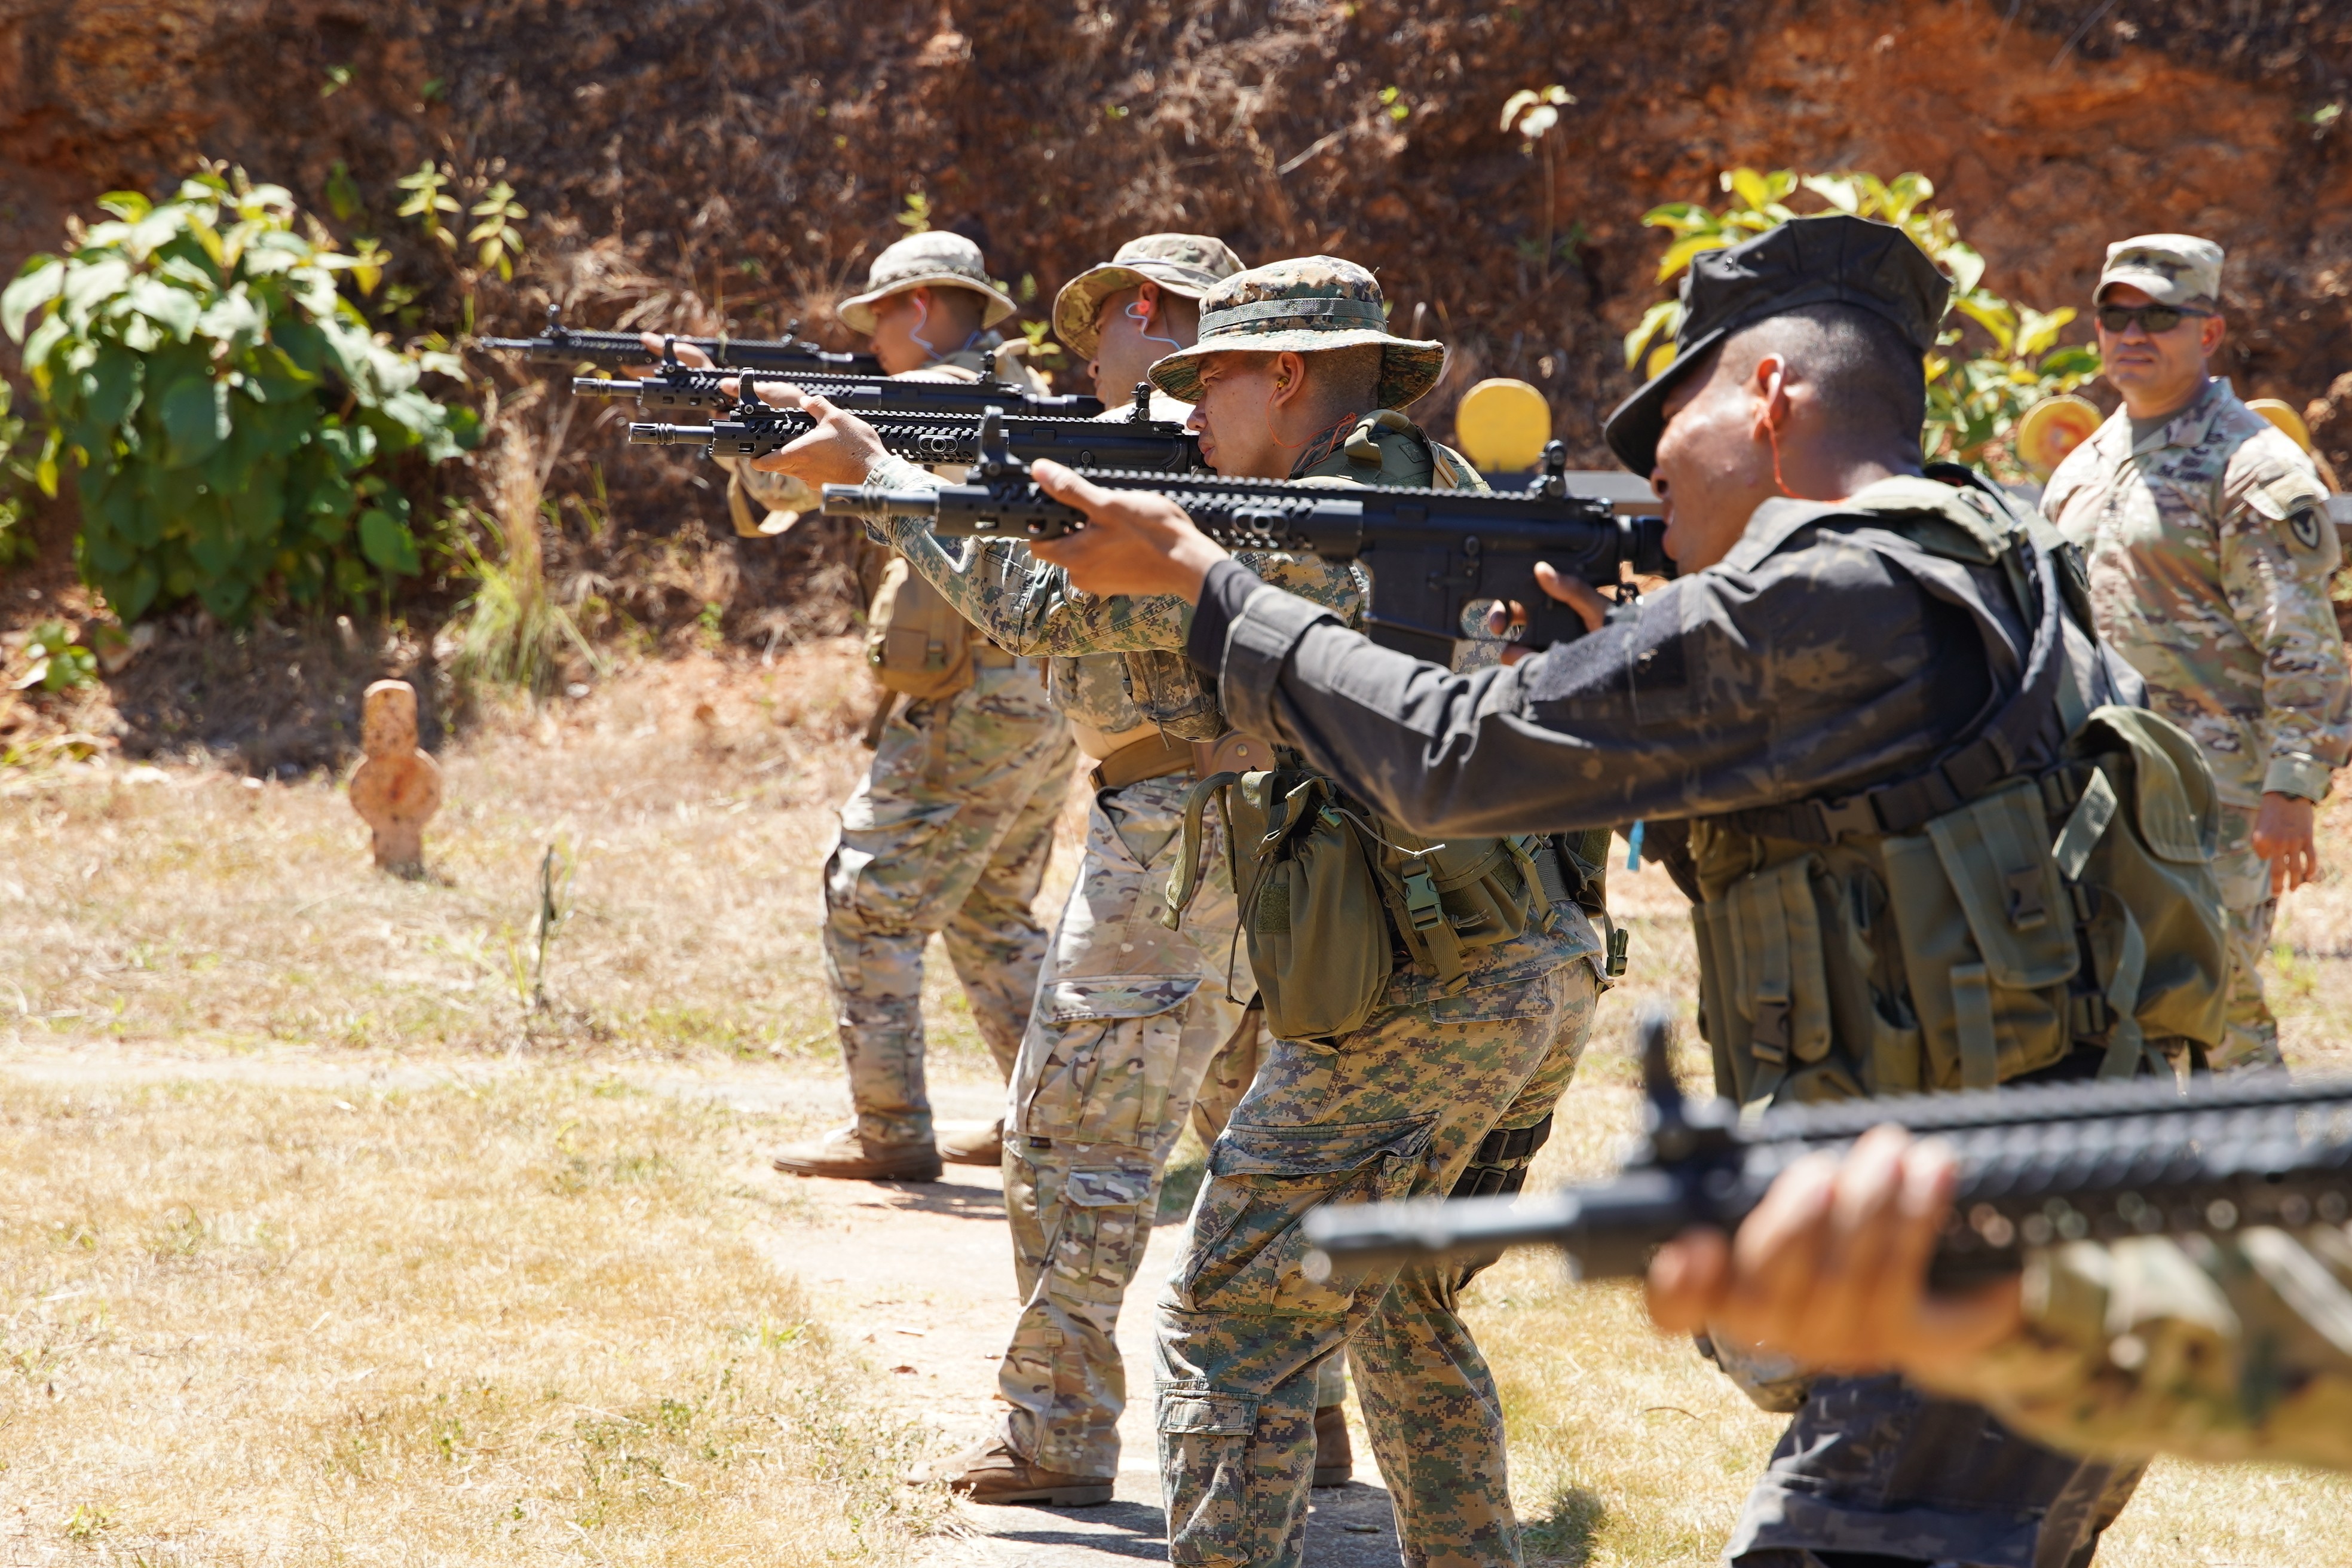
[1155,914,1599,1568]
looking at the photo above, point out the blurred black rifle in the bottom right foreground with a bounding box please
[1305,1013,2352,1288]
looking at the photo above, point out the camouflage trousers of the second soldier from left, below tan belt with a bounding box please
[997,776,1288,1477]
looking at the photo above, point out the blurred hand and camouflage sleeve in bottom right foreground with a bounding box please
[1649,1126,2352,1472]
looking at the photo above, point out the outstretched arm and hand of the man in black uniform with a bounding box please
[1037,463,1990,835]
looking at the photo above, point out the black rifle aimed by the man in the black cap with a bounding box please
[826,421,1674,660]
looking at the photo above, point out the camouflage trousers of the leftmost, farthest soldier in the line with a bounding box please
[823,663,1077,1143]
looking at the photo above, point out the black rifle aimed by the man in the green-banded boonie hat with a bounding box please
[628,405,1202,472]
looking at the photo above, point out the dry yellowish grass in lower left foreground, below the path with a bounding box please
[0,1077,936,1568]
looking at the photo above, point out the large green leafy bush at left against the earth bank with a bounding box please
[0,167,480,621]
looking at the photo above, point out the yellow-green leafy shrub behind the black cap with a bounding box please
[1625,169,2098,480]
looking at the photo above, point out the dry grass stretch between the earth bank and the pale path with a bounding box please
[0,639,1067,1067]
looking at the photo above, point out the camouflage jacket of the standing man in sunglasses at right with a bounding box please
[2041,381,2352,806]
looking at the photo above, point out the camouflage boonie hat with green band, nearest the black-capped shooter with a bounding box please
[1134,256,1447,409]
